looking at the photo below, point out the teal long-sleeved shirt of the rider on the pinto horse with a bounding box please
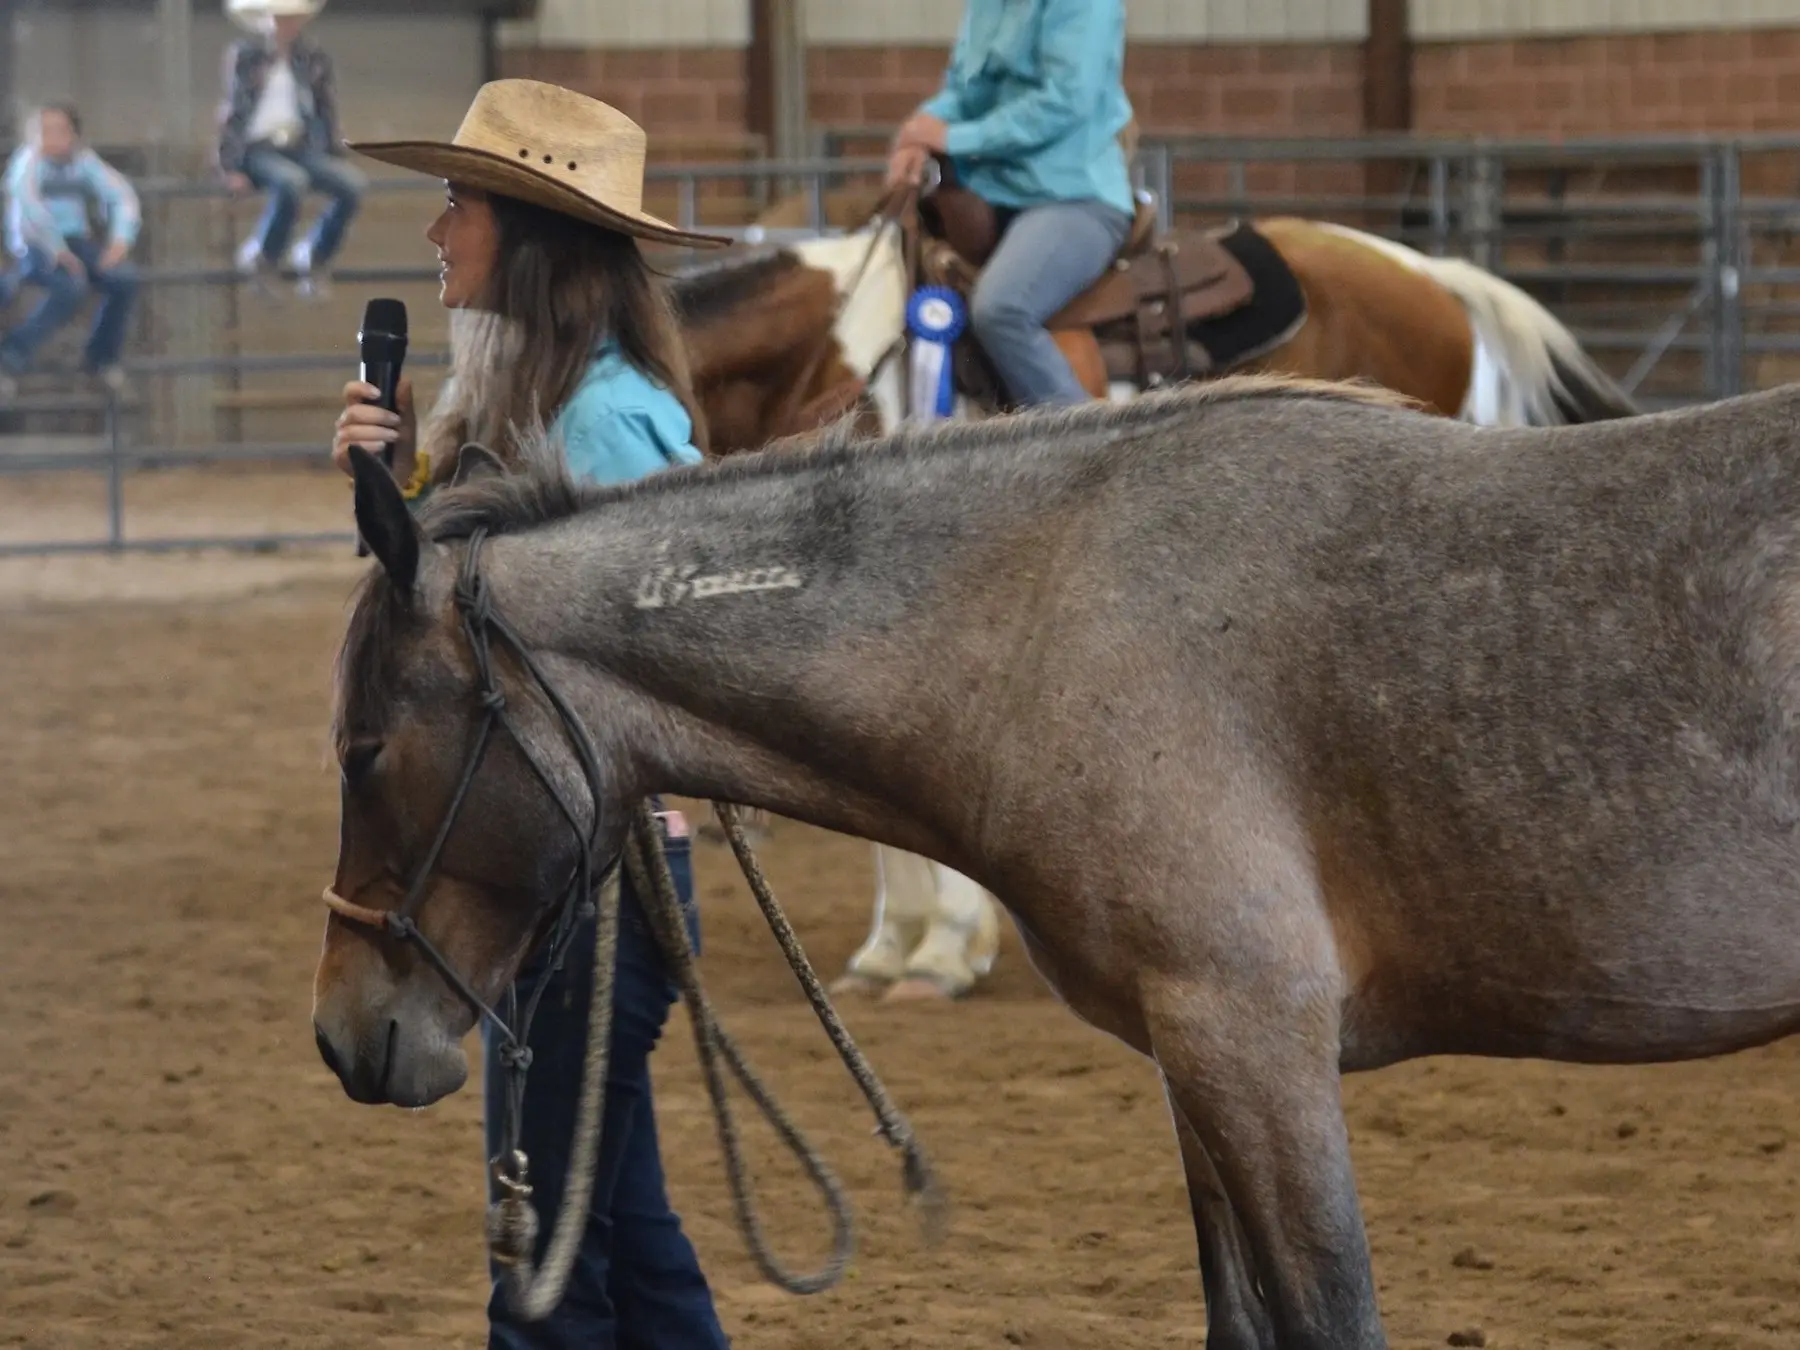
[923,0,1136,214]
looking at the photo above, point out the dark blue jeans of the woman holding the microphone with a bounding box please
[484,824,731,1350]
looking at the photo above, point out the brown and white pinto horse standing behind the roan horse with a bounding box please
[677,193,1636,1001]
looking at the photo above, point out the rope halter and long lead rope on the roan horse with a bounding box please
[324,529,943,1321]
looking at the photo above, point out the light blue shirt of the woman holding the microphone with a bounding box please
[551,342,702,482]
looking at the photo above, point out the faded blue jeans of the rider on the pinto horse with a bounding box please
[968,202,1132,407]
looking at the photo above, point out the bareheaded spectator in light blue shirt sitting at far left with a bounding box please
[0,103,142,398]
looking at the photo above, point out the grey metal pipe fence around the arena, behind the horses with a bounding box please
[10,128,1800,554]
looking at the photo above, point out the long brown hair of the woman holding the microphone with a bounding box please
[419,193,707,481]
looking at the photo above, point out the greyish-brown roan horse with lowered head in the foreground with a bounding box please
[313,378,1800,1350]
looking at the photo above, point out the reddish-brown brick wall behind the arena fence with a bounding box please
[504,29,1800,216]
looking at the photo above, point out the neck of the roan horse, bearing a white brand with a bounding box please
[486,428,1055,860]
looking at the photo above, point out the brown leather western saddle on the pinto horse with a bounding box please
[916,158,1281,407]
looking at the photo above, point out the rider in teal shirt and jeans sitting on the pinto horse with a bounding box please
[887,0,1136,407]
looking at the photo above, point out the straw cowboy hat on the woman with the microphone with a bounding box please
[349,79,731,248]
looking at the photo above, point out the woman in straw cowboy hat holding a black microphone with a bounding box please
[333,79,727,1350]
